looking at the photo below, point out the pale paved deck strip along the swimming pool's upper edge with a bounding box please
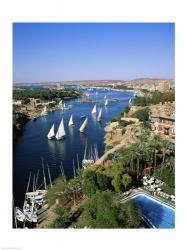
[123,188,175,209]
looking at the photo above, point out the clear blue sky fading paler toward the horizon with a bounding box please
[13,23,175,83]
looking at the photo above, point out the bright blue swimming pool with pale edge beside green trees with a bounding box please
[123,194,175,229]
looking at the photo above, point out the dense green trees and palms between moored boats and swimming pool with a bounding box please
[47,131,175,228]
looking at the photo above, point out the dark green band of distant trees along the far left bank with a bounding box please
[13,89,81,102]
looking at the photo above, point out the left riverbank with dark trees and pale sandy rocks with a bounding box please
[13,89,83,140]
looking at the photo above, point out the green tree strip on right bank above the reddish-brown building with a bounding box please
[134,90,175,107]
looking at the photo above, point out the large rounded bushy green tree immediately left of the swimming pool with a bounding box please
[83,190,141,228]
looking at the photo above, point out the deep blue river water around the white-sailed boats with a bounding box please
[13,89,133,207]
